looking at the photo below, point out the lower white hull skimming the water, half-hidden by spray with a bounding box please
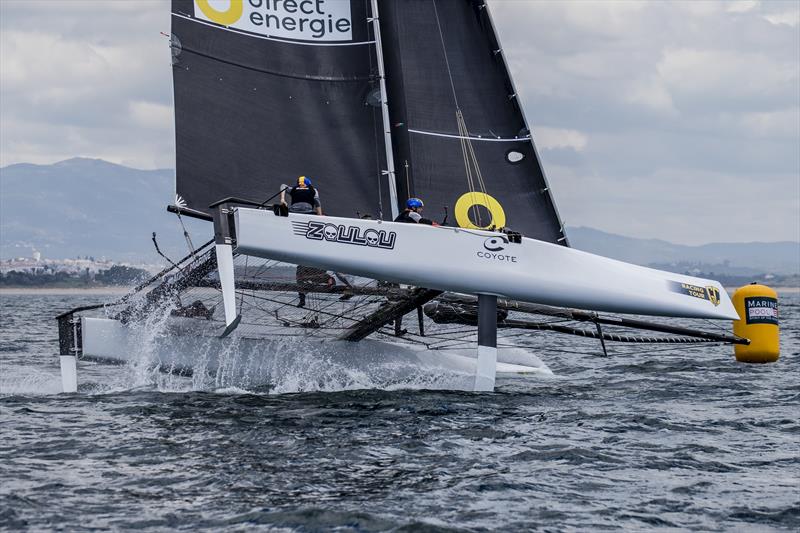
[81,317,550,392]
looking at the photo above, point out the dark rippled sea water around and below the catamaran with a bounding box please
[0,294,800,531]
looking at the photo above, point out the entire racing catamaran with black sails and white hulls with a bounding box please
[58,0,748,391]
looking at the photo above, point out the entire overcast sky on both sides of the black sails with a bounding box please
[0,0,800,244]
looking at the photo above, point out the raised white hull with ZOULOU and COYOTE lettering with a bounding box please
[235,208,738,319]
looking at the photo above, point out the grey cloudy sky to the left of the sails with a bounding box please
[0,1,174,168]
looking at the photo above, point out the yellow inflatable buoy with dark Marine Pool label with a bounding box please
[733,283,780,363]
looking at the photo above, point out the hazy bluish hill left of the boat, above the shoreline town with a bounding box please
[0,158,206,262]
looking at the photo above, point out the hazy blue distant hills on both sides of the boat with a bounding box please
[0,158,800,275]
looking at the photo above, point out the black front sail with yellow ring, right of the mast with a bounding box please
[380,0,566,244]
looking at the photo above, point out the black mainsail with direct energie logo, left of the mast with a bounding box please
[172,0,391,218]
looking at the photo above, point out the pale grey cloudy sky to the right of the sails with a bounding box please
[492,1,800,243]
